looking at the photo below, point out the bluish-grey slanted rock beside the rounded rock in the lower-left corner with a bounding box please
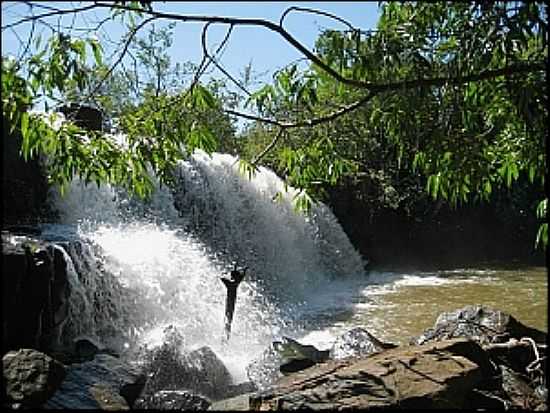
[44,354,145,410]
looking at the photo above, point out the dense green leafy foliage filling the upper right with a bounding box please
[242,2,548,245]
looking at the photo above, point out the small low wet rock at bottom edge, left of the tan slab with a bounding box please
[134,390,210,410]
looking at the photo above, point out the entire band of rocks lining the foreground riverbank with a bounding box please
[3,306,547,410]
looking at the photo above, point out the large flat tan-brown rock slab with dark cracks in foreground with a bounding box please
[250,339,489,410]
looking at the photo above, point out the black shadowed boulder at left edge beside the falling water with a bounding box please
[2,232,70,353]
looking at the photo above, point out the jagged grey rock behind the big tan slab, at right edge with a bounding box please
[411,305,547,344]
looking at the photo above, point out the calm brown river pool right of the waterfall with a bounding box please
[302,267,548,348]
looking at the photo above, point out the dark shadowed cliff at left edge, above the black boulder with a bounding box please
[2,119,48,227]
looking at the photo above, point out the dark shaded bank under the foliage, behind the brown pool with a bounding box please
[328,184,545,270]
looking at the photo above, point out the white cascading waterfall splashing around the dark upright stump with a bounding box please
[45,151,364,381]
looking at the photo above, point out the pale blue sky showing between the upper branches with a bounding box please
[1,1,379,85]
